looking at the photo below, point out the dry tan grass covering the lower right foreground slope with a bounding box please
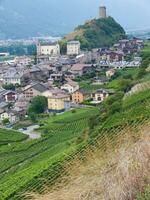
[31,121,150,200]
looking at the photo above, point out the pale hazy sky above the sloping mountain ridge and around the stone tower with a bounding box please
[0,0,150,29]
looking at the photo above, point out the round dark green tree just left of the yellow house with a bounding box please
[28,96,48,117]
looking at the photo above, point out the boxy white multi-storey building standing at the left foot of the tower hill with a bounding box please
[67,41,80,56]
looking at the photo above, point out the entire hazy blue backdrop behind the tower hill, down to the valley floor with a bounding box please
[0,0,150,38]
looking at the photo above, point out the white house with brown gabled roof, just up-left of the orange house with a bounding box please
[61,79,79,94]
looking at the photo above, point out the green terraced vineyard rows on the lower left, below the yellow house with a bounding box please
[0,108,99,200]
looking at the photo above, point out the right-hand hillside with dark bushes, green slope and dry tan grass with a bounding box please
[22,42,150,200]
